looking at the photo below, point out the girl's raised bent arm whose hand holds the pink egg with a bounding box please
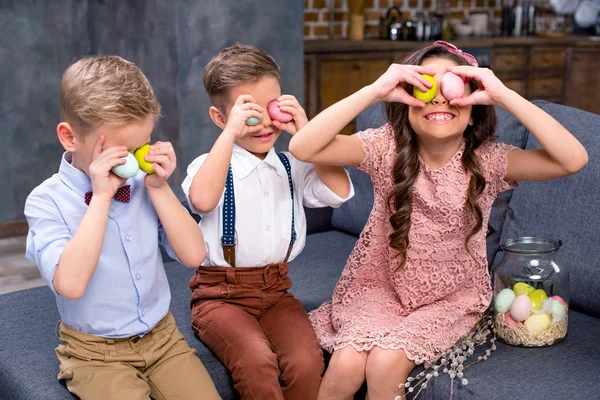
[449,66,588,181]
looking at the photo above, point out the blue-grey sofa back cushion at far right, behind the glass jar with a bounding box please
[502,102,600,316]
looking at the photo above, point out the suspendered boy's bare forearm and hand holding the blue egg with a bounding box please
[189,95,264,213]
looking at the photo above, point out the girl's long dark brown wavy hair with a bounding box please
[385,46,497,269]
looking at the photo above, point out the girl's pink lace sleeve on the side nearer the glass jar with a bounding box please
[478,143,519,194]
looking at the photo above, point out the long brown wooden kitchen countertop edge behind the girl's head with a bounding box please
[304,36,600,54]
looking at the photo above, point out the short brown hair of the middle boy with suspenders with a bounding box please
[204,43,281,112]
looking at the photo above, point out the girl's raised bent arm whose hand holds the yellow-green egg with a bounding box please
[290,64,435,166]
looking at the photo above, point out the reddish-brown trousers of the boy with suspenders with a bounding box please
[190,263,324,400]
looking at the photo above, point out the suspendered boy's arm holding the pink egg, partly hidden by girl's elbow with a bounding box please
[273,95,351,199]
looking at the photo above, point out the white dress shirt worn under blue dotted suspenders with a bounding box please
[181,145,354,267]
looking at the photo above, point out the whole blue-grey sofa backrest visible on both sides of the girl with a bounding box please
[332,101,600,316]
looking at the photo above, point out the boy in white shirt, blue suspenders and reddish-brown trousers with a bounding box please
[182,44,354,400]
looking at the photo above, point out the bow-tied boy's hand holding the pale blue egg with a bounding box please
[88,135,128,201]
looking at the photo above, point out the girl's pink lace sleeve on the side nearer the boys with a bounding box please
[353,124,394,177]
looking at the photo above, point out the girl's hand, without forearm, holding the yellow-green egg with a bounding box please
[371,64,436,107]
